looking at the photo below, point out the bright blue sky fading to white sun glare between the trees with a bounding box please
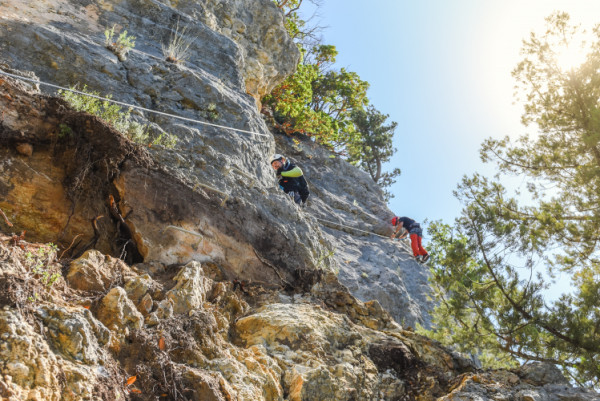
[303,0,600,223]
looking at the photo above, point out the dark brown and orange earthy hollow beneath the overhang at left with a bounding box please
[0,74,140,253]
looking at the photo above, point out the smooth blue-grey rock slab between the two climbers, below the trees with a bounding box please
[276,136,433,328]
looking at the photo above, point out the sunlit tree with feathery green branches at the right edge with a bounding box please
[422,13,600,387]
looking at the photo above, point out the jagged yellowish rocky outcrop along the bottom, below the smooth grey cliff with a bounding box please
[0,240,598,401]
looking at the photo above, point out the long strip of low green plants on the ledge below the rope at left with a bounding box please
[58,85,177,148]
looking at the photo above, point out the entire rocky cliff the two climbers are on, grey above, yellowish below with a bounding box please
[0,0,598,401]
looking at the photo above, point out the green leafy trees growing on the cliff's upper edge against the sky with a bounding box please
[263,0,400,198]
